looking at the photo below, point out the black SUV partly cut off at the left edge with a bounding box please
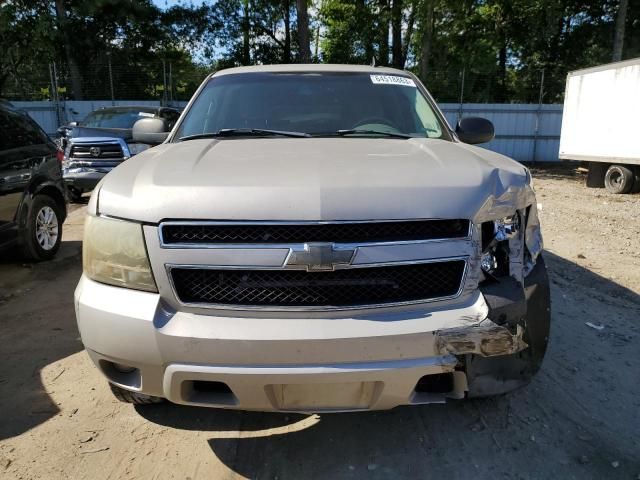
[0,102,67,260]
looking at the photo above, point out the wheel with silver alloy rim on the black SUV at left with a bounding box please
[21,195,62,261]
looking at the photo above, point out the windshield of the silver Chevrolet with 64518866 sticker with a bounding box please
[174,72,448,141]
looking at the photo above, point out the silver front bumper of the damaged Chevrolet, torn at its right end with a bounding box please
[75,276,526,411]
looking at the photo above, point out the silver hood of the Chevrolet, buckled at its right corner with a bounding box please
[92,137,533,223]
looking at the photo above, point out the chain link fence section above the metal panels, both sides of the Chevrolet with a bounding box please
[0,60,562,105]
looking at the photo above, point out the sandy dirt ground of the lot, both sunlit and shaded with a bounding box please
[0,169,640,480]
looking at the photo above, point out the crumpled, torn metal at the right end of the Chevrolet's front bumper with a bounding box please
[435,318,528,357]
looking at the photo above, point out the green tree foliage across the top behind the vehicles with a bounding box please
[0,0,640,102]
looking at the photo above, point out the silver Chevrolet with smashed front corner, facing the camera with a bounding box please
[75,65,550,412]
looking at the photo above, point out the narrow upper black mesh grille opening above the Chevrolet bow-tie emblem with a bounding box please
[161,220,469,245]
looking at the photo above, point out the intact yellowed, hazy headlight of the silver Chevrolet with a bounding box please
[82,216,158,292]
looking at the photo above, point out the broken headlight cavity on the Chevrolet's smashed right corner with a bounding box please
[480,213,520,277]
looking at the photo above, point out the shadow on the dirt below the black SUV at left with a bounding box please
[0,241,83,440]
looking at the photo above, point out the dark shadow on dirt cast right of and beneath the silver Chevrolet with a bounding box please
[136,252,640,479]
